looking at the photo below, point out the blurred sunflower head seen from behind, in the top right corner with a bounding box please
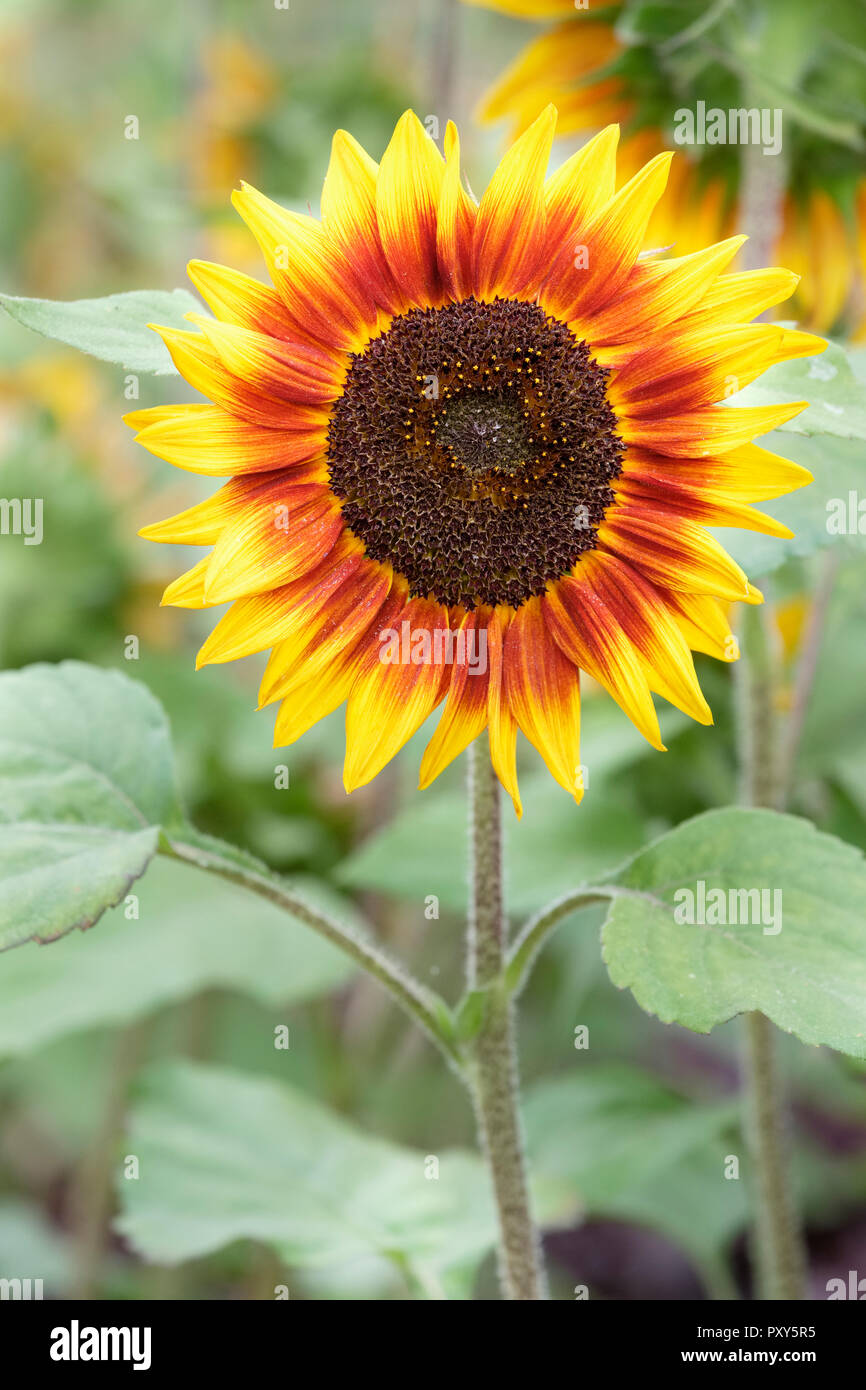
[464,0,866,332]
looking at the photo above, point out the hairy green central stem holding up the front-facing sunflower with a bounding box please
[467,741,546,1300]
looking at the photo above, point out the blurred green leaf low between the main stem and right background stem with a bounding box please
[524,1054,746,1269]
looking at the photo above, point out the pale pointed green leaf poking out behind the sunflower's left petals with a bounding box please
[0,289,202,377]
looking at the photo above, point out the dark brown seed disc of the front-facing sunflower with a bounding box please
[328,299,624,607]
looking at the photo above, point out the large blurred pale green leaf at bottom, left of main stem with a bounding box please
[117,1062,495,1298]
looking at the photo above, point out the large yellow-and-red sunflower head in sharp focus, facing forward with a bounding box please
[126,116,824,813]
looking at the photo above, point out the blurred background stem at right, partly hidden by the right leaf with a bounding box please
[738,607,806,1300]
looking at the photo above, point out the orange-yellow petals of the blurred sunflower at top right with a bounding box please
[463,0,866,332]
